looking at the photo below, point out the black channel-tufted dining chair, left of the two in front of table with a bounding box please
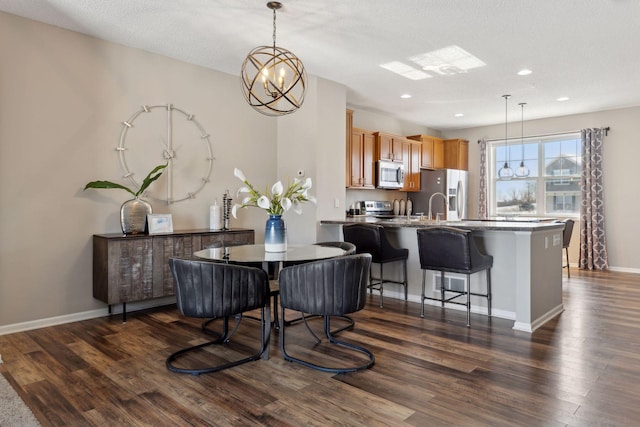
[166,258,271,376]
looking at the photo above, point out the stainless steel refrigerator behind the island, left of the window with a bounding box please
[407,169,469,221]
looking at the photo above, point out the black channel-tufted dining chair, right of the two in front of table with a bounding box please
[280,254,375,373]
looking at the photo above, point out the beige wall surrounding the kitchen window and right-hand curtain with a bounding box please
[444,107,640,273]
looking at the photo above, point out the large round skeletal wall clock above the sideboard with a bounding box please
[116,104,213,204]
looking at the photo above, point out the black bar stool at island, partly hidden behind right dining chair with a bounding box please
[342,224,409,308]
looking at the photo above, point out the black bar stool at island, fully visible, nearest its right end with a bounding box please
[417,227,493,326]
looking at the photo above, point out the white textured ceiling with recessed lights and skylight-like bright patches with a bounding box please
[0,0,640,130]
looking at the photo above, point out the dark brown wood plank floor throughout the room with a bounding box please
[0,269,640,426]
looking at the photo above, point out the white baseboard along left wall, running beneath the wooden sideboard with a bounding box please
[0,297,176,335]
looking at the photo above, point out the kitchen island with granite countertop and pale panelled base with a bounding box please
[320,216,564,332]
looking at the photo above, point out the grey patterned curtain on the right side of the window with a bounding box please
[579,129,609,270]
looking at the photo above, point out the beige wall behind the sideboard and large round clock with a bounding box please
[0,13,346,334]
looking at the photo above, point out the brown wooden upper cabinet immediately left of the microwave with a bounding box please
[347,128,376,189]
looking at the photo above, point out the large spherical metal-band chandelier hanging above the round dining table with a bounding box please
[241,1,307,116]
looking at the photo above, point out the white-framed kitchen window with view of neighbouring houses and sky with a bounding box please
[488,133,582,216]
